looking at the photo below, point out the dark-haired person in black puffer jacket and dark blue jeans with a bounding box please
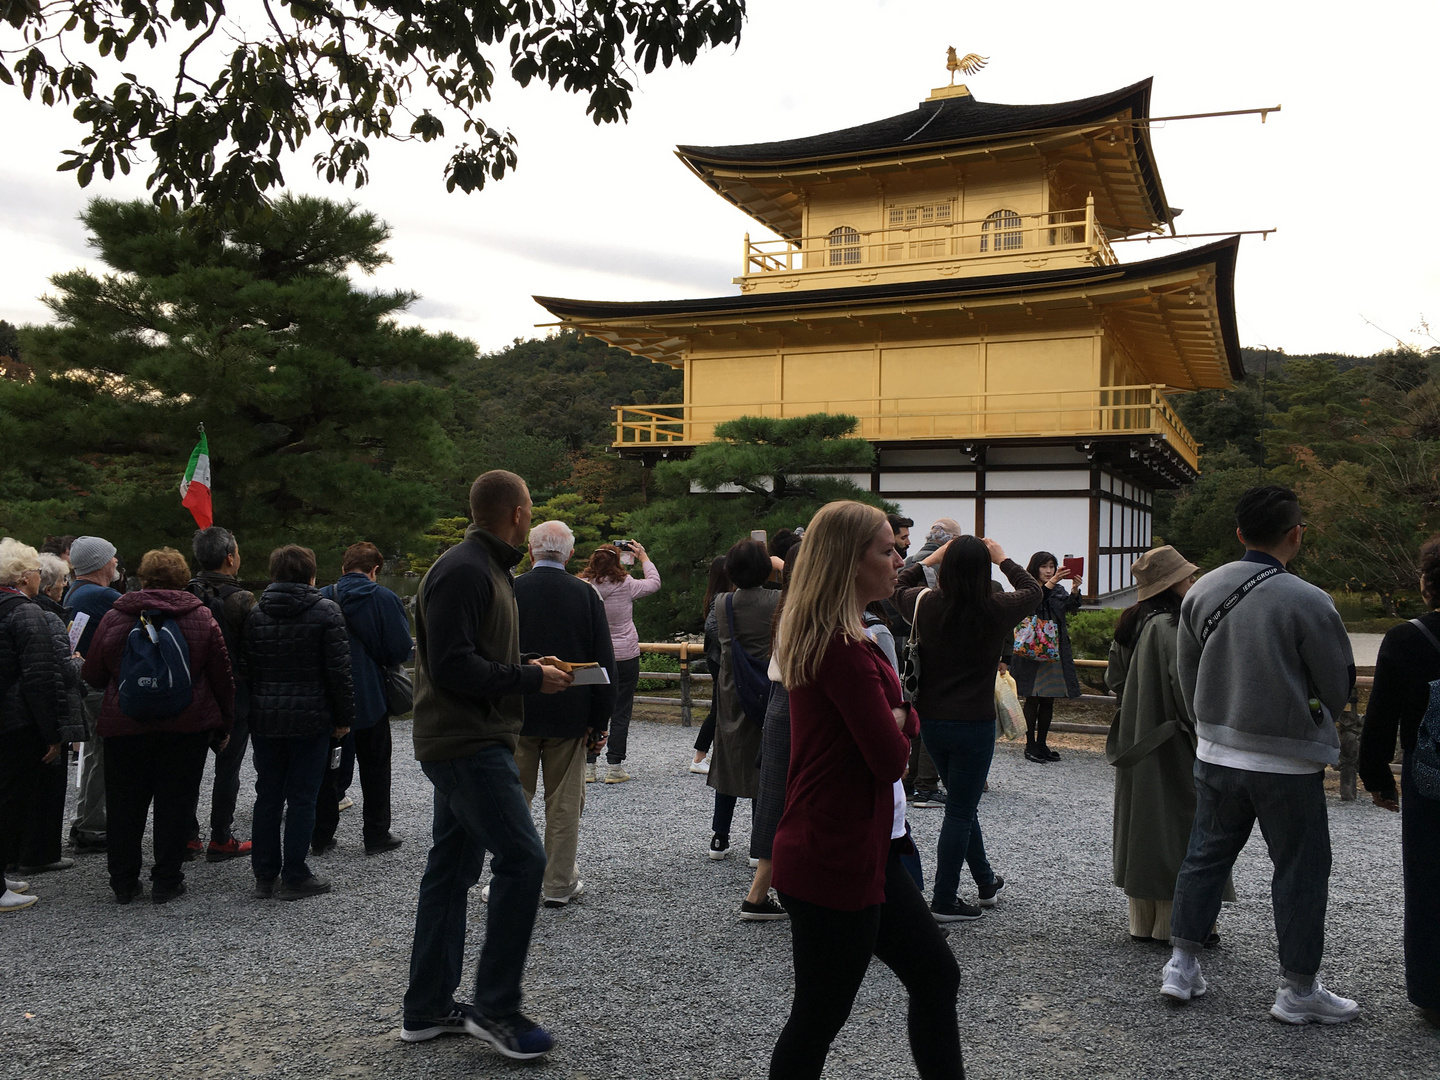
[243,544,356,900]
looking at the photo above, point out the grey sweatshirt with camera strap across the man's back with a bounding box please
[1179,562,1355,765]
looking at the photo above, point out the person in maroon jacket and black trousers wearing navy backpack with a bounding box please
[81,547,235,904]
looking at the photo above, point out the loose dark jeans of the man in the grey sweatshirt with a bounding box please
[1171,760,1331,985]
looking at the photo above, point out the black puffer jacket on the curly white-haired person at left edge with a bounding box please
[0,592,69,746]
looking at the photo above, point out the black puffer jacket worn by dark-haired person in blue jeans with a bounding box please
[243,582,356,739]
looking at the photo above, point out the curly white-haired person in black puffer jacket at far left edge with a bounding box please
[0,537,69,913]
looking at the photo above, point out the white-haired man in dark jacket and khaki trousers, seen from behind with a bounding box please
[516,521,616,907]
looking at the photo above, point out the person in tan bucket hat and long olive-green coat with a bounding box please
[1104,544,1236,942]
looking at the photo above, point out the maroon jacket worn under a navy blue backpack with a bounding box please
[81,589,235,737]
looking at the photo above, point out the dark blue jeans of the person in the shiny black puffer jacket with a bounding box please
[251,733,330,884]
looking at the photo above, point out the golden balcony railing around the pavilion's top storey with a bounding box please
[742,196,1117,276]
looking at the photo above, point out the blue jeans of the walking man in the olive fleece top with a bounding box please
[405,744,544,1020]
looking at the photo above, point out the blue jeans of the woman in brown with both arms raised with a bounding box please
[920,717,995,904]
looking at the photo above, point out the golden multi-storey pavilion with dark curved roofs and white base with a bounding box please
[536,72,1243,603]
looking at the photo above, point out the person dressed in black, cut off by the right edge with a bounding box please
[1359,536,1440,1027]
